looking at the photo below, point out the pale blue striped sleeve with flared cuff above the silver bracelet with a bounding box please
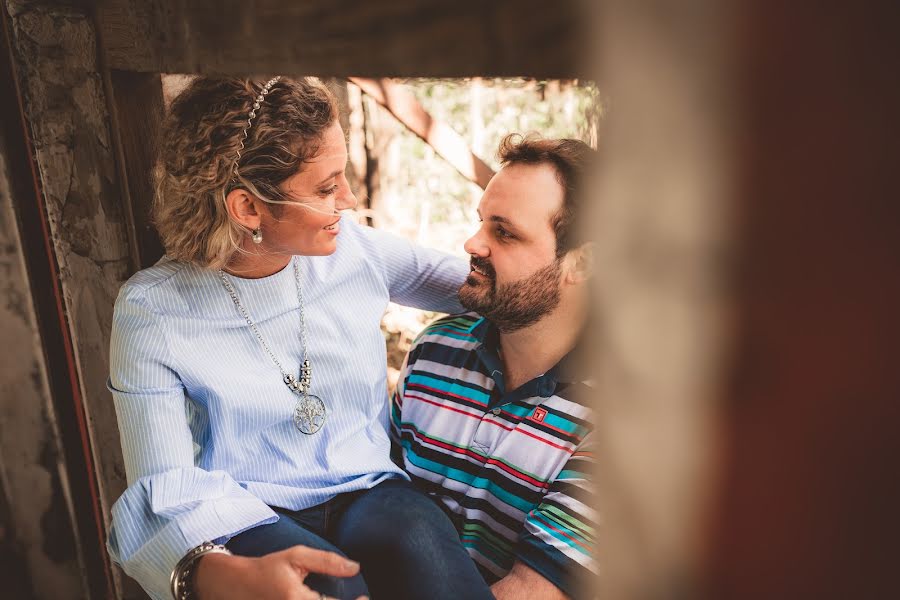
[107,284,278,599]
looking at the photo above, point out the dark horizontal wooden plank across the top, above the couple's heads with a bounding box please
[96,0,589,78]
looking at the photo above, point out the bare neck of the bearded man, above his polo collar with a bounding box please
[500,304,586,391]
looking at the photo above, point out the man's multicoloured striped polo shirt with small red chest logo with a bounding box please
[391,313,596,596]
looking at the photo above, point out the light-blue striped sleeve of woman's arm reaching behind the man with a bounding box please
[362,219,469,314]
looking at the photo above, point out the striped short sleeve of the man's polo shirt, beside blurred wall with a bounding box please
[516,433,596,598]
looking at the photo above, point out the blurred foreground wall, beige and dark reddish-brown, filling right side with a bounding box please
[592,0,900,600]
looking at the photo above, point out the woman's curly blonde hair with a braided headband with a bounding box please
[153,77,338,269]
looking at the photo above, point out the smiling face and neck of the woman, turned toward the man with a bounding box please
[261,121,356,256]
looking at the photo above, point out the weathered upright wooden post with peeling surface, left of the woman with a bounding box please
[3,0,133,598]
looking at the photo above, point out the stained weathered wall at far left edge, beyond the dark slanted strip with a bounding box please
[0,103,86,600]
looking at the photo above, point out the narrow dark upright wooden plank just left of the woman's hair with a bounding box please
[109,71,165,269]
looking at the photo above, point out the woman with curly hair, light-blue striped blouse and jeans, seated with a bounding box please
[109,78,491,600]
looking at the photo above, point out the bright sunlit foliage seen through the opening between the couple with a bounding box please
[367,79,601,255]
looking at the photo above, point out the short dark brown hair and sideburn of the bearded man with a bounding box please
[499,133,597,257]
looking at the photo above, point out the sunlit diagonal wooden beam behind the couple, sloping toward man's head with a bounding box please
[350,77,494,189]
